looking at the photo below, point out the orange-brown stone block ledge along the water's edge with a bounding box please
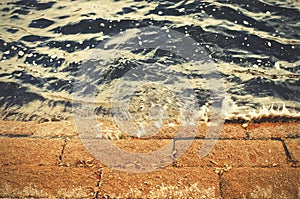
[0,121,300,198]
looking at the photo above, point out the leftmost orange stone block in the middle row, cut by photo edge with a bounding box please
[0,137,64,167]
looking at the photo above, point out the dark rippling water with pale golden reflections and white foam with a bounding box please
[0,0,300,121]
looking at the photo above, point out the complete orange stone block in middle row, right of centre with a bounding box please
[175,140,287,167]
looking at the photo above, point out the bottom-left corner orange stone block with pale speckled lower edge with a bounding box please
[0,165,97,198]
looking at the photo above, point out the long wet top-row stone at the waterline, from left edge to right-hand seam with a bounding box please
[0,119,245,139]
